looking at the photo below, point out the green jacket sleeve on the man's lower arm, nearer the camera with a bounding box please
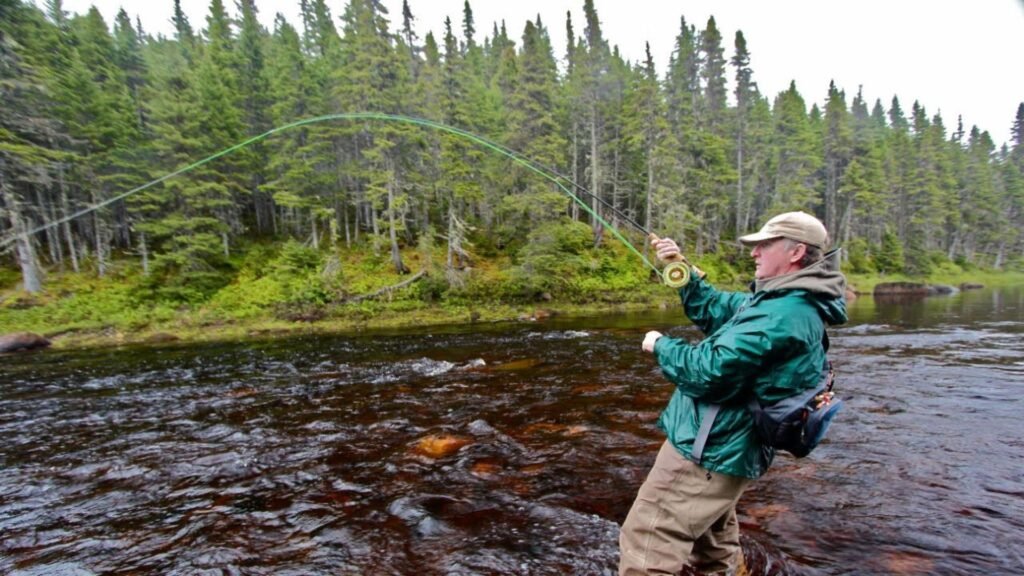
[654,308,801,403]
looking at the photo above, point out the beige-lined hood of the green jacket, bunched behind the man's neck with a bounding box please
[754,248,847,325]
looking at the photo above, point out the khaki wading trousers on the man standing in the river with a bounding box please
[618,441,751,576]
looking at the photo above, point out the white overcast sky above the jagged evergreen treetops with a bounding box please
[54,0,1024,146]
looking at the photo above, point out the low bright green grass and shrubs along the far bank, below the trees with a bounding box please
[0,239,1024,347]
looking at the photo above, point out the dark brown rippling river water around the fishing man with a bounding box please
[0,288,1024,576]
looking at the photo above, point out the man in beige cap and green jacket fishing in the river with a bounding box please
[618,212,846,576]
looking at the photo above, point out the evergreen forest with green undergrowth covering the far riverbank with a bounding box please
[0,0,1024,344]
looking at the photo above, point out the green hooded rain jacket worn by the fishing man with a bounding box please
[654,250,847,479]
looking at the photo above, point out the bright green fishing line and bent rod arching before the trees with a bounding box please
[0,112,658,272]
